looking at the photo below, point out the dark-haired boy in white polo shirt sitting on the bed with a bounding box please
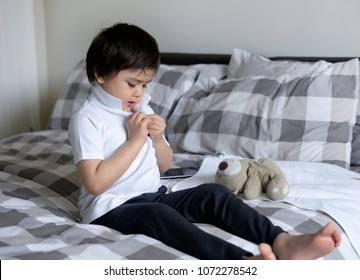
[69,23,341,259]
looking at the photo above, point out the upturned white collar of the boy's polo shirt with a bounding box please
[92,83,151,114]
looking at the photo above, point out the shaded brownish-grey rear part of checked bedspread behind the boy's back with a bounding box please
[0,130,80,207]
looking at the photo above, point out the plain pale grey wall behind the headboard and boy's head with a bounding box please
[44,0,360,127]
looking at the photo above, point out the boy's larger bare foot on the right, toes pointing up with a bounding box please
[273,223,341,260]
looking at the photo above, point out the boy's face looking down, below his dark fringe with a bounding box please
[96,69,155,112]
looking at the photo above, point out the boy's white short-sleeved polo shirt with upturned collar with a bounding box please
[68,85,161,223]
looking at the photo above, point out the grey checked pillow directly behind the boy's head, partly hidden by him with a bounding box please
[48,60,227,129]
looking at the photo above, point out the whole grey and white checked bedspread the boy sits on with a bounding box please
[0,130,359,259]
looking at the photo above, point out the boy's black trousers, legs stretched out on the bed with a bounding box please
[92,184,284,260]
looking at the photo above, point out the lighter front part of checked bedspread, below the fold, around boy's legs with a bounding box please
[0,171,356,260]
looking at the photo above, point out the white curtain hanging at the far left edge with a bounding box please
[0,0,40,138]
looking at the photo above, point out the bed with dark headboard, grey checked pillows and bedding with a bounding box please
[0,49,360,260]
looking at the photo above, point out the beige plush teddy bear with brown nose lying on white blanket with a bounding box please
[215,158,290,200]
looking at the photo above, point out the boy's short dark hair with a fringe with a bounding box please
[86,23,160,83]
